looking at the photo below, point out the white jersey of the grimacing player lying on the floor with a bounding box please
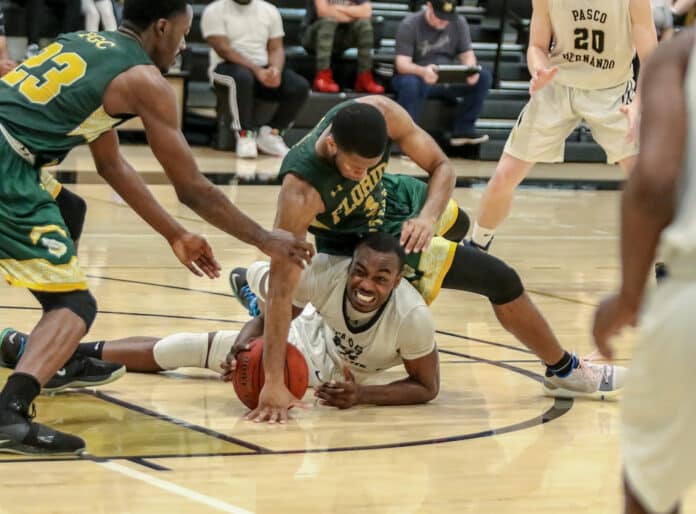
[247,254,435,382]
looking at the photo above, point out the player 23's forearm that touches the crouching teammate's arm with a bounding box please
[177,179,268,250]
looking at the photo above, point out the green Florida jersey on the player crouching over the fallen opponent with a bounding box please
[280,100,390,255]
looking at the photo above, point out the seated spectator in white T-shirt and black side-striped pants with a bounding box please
[201,0,309,158]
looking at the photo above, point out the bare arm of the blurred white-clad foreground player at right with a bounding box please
[593,28,694,357]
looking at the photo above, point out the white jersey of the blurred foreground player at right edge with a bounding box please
[661,40,696,278]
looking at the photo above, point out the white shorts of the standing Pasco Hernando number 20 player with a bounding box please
[503,80,638,164]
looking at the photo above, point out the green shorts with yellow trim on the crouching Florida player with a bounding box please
[315,173,459,304]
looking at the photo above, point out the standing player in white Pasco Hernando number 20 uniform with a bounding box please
[471,0,657,249]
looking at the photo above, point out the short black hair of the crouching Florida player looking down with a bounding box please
[331,102,388,159]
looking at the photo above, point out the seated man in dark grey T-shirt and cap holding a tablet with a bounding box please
[392,0,493,146]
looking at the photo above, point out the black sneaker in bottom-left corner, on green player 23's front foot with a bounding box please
[0,402,85,455]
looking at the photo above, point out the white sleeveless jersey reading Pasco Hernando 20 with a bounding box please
[548,0,635,89]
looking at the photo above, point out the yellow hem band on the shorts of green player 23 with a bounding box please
[0,256,88,292]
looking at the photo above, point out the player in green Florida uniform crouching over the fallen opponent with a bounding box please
[249,96,624,422]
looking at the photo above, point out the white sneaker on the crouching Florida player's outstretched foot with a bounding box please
[544,359,627,400]
